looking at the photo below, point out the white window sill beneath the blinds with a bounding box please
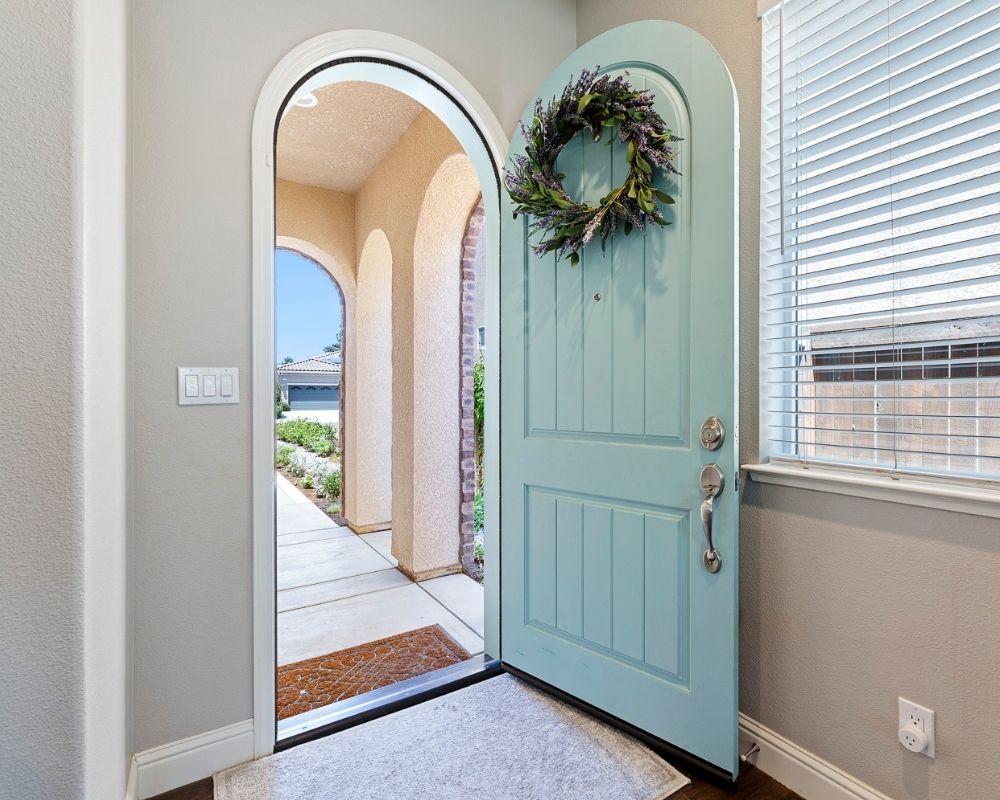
[743,462,1000,518]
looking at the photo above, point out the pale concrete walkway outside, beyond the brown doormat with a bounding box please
[277,474,483,666]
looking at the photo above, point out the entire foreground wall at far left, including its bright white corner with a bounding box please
[0,0,131,800]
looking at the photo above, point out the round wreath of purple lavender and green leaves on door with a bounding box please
[504,67,680,266]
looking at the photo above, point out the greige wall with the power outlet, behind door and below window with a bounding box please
[577,0,1000,800]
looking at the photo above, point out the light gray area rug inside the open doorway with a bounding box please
[215,675,689,800]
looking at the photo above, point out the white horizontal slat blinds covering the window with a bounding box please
[761,0,1000,479]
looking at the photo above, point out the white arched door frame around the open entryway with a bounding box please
[250,30,509,758]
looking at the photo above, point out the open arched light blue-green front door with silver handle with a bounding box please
[501,22,739,774]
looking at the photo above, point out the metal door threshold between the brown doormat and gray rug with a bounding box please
[274,656,503,753]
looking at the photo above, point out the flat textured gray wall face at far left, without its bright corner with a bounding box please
[0,0,83,800]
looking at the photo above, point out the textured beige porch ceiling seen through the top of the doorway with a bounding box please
[277,81,423,194]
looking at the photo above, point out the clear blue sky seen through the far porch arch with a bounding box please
[274,250,343,363]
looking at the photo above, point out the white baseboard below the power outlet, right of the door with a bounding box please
[740,713,892,800]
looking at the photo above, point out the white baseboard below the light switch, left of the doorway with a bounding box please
[135,719,254,800]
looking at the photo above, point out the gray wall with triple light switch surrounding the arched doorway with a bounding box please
[131,0,575,750]
